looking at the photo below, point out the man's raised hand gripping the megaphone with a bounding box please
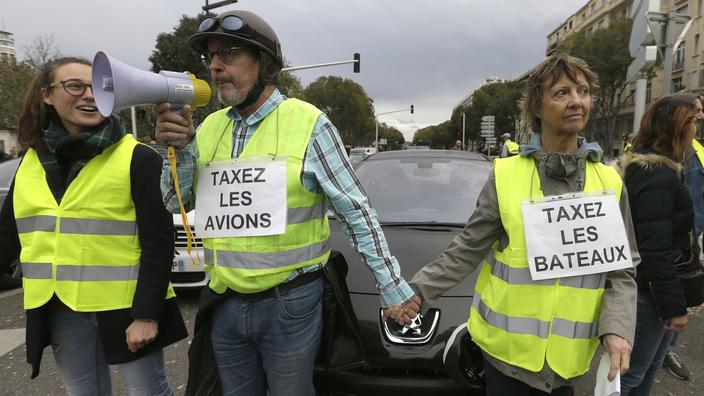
[154,102,196,149]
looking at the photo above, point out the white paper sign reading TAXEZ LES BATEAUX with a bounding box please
[521,193,633,280]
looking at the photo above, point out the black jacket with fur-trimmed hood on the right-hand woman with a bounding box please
[621,150,694,320]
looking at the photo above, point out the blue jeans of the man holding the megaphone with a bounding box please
[212,277,324,396]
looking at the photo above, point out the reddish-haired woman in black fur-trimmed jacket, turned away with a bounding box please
[620,96,698,396]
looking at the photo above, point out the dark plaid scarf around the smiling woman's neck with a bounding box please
[35,116,125,203]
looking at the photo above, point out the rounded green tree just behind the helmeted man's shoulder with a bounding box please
[303,76,374,147]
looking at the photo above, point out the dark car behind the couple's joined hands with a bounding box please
[316,150,491,396]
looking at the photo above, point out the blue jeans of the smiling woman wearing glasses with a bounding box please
[50,309,174,396]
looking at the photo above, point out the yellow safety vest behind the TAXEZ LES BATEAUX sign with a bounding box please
[468,156,622,378]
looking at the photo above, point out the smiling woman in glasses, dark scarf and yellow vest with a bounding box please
[0,57,187,395]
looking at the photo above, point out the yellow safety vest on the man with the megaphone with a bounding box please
[196,99,330,293]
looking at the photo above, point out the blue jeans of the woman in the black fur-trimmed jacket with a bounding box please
[621,290,674,396]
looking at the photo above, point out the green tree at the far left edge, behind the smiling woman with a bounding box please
[0,59,35,130]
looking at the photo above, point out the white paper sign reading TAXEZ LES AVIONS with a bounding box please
[195,159,288,238]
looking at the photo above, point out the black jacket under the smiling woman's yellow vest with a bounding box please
[0,144,188,378]
